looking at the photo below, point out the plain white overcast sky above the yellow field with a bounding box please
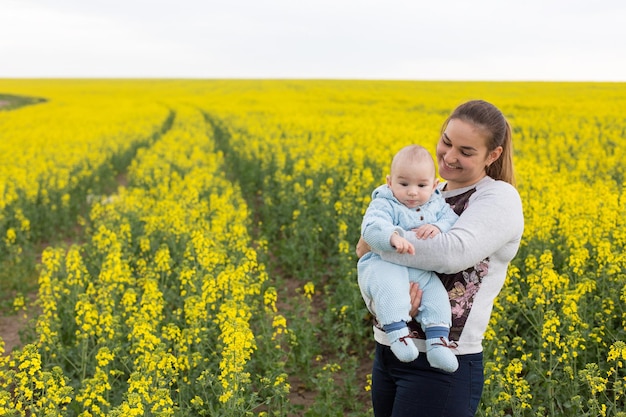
[0,0,626,81]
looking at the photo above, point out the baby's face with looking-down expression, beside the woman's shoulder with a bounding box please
[387,162,437,209]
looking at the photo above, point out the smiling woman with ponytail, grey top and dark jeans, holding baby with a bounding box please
[357,100,524,417]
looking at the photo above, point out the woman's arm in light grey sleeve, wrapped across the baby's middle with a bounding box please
[380,181,524,273]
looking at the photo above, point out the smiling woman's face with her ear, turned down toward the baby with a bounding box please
[437,119,502,190]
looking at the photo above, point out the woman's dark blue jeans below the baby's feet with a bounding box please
[372,343,484,417]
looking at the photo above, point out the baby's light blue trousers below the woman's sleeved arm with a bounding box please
[357,252,452,328]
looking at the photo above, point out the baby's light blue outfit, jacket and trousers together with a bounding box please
[357,184,458,337]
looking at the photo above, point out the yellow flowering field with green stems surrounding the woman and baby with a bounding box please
[0,79,626,417]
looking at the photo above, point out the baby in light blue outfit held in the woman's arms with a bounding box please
[358,145,458,372]
